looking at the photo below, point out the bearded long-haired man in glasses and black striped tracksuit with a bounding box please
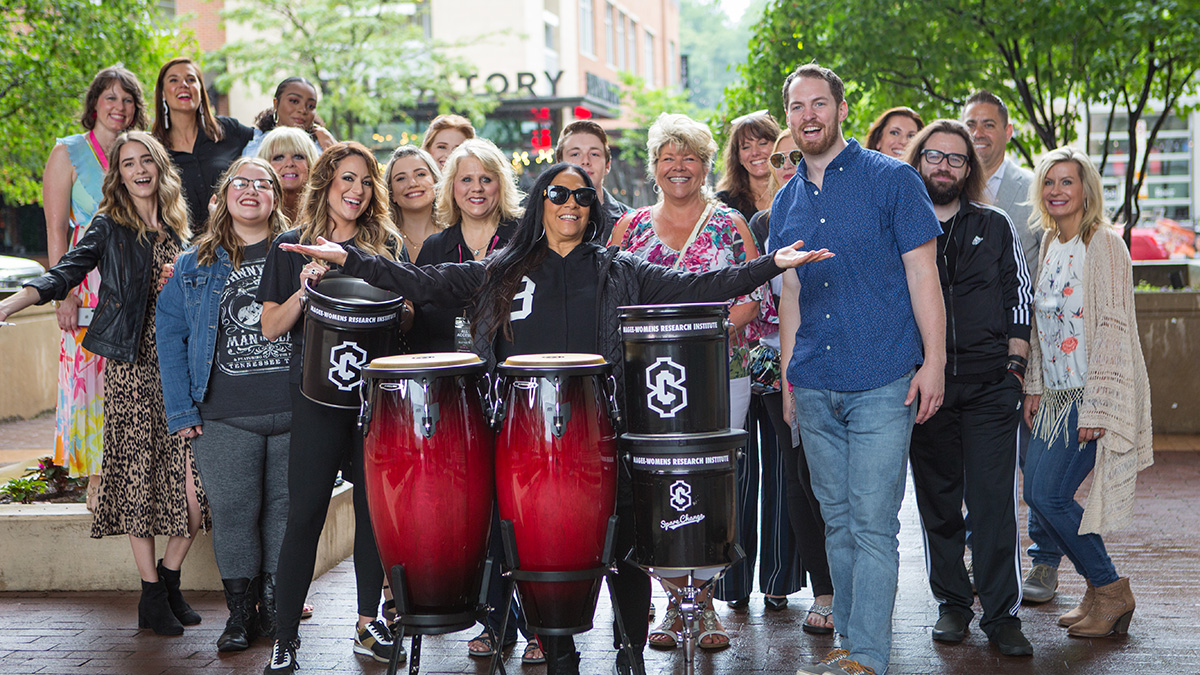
[905,120,1033,656]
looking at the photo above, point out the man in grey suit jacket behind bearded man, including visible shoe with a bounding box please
[962,89,1062,604]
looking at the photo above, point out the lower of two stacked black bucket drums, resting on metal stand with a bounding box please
[620,429,746,579]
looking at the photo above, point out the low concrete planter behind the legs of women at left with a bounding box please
[0,484,354,591]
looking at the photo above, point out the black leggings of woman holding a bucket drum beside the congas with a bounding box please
[275,384,383,640]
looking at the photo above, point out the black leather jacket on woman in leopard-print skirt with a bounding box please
[25,214,179,362]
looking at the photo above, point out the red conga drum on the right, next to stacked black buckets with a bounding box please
[496,354,617,635]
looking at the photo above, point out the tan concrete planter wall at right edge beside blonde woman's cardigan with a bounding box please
[1134,289,1200,434]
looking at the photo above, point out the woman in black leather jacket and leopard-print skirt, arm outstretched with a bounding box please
[0,131,204,635]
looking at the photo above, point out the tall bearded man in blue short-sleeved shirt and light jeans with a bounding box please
[769,64,946,675]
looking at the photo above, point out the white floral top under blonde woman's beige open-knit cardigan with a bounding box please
[1033,237,1087,390]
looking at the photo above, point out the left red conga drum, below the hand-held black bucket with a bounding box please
[362,353,494,633]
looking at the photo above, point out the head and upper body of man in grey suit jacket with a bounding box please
[962,90,1042,275]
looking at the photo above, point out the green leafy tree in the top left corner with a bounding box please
[0,0,184,204]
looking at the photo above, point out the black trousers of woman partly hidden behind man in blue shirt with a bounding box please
[762,393,833,596]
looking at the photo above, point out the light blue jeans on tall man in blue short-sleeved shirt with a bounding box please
[792,371,917,675]
